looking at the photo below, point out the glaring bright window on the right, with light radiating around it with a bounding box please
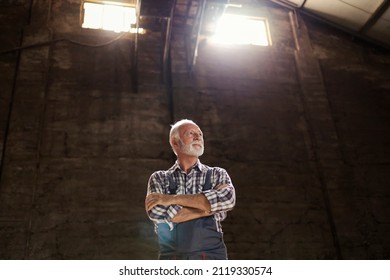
[213,14,271,46]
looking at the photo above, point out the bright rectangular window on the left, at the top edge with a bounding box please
[82,2,137,32]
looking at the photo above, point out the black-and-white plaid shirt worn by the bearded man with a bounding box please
[147,160,236,232]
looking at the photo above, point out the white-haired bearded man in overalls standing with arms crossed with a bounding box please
[145,119,236,260]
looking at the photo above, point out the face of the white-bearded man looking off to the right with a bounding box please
[179,124,204,157]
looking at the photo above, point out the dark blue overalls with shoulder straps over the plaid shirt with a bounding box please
[157,169,227,260]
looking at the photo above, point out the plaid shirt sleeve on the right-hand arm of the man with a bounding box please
[204,168,236,213]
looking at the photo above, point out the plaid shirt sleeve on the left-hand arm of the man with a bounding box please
[147,171,183,223]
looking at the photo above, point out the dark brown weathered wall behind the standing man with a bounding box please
[0,1,390,259]
